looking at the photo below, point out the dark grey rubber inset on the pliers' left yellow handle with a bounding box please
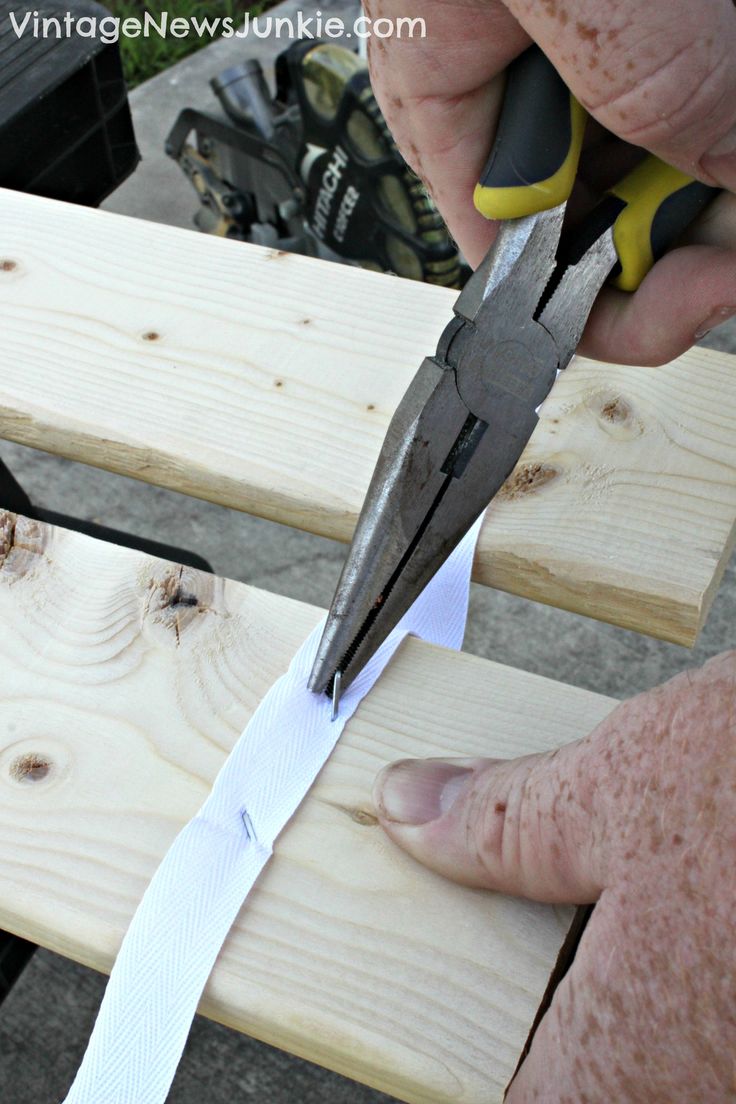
[479,46,573,188]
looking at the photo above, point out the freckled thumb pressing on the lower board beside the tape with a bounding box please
[374,741,607,904]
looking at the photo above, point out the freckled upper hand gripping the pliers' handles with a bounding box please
[366,0,736,364]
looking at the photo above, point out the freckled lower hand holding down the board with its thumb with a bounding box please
[374,651,736,1104]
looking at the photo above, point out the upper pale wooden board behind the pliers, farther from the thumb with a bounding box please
[0,184,736,644]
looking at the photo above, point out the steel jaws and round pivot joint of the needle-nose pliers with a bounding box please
[309,211,563,692]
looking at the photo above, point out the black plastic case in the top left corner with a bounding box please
[0,0,139,206]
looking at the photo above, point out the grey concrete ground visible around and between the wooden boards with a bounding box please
[0,15,736,1104]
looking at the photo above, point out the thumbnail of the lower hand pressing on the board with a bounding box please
[373,760,473,825]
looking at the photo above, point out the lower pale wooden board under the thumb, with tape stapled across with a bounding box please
[0,514,614,1104]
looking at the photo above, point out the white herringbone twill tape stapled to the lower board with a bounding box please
[65,518,482,1104]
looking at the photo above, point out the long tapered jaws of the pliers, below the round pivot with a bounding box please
[309,344,536,693]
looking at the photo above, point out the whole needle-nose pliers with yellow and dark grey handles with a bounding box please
[309,47,716,693]
